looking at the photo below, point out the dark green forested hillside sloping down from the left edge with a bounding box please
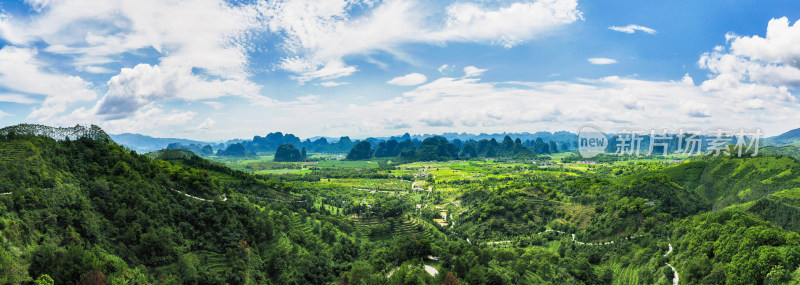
[0,131,352,284]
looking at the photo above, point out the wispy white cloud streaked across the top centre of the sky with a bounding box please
[261,0,582,83]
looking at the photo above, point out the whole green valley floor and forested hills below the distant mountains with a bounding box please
[0,127,800,284]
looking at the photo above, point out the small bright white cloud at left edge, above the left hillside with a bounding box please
[0,46,97,120]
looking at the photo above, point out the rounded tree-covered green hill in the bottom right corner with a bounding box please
[672,210,800,284]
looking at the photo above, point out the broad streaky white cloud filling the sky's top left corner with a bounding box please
[0,0,260,79]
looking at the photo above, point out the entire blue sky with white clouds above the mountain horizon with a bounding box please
[0,0,800,140]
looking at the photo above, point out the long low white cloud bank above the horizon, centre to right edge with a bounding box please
[290,68,798,136]
